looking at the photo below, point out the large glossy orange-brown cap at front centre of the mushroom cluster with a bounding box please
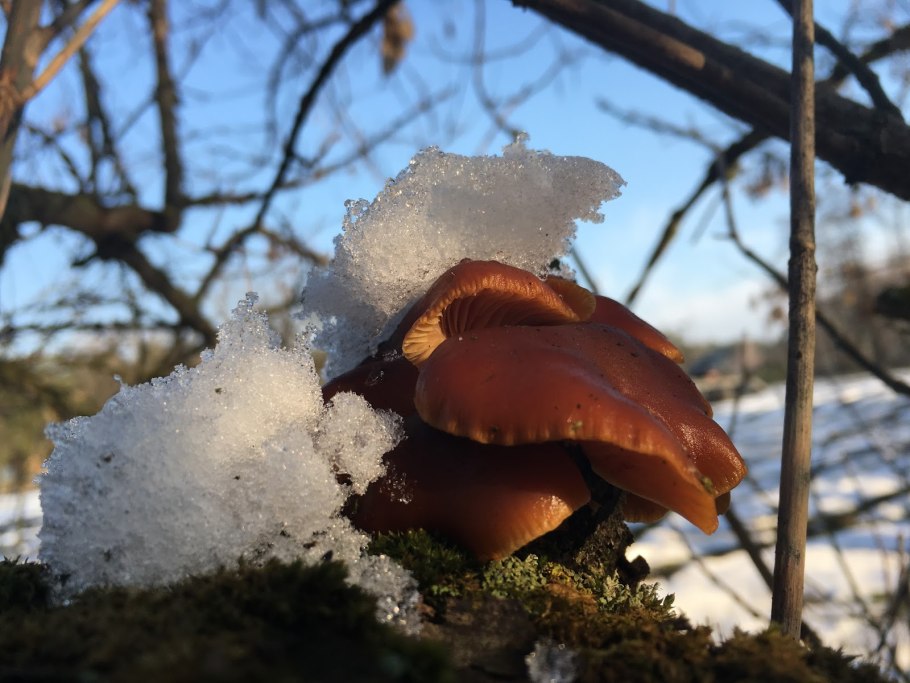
[414,323,745,533]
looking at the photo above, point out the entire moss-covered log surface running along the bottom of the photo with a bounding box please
[0,544,886,683]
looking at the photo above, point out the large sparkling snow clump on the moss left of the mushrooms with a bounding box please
[39,294,418,632]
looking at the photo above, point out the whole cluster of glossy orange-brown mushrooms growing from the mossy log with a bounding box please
[323,260,746,559]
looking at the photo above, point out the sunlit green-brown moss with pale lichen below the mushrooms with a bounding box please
[373,531,886,683]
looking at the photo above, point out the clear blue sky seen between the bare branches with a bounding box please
[0,0,904,352]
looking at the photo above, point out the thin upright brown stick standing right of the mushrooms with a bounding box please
[771,0,817,639]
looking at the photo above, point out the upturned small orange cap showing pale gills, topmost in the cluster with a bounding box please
[399,259,594,367]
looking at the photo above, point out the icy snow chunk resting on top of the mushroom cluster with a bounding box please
[303,139,624,376]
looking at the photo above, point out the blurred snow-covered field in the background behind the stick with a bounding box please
[0,372,910,671]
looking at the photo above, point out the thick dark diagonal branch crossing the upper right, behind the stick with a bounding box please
[513,0,910,199]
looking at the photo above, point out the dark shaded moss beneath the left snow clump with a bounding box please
[0,562,451,681]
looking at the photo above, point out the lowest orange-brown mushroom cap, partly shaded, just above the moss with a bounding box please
[353,416,591,560]
